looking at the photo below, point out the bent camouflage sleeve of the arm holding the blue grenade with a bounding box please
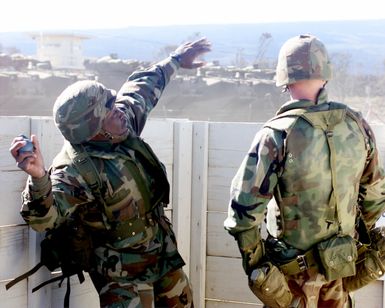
[21,168,94,232]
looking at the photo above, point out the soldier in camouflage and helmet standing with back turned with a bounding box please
[224,35,385,307]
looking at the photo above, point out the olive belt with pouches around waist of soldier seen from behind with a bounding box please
[265,235,358,281]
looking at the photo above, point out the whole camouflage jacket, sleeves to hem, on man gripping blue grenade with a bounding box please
[21,59,192,307]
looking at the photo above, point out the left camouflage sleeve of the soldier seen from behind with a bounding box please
[224,128,283,235]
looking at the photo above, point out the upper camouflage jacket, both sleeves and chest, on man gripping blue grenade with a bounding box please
[21,59,179,247]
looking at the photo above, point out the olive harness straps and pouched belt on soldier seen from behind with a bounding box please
[265,102,370,281]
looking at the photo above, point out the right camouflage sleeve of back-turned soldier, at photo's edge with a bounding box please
[359,120,385,229]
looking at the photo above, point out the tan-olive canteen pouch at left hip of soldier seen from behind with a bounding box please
[249,262,293,308]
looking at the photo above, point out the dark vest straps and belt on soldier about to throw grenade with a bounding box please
[54,137,170,249]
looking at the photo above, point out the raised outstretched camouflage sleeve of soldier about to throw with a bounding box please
[116,57,180,135]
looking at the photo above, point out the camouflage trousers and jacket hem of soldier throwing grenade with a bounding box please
[89,217,193,308]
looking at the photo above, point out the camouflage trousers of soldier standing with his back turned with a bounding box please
[287,268,354,308]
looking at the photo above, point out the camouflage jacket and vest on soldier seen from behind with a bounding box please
[224,87,385,250]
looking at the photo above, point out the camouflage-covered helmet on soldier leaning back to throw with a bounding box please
[53,80,116,144]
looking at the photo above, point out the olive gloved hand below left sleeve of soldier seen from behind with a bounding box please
[235,227,265,276]
